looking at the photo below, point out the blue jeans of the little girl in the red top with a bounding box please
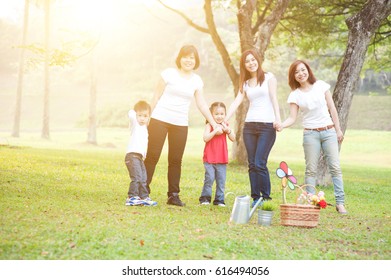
[200,162,227,204]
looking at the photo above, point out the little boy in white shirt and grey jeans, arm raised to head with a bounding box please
[125,101,157,206]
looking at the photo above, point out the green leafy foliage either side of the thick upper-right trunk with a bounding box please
[271,0,391,76]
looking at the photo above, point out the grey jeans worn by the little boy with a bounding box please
[125,153,149,199]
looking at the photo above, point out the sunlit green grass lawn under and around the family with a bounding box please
[0,128,391,260]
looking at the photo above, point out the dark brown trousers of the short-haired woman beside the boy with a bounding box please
[144,119,188,197]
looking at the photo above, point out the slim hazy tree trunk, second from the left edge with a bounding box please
[41,0,50,139]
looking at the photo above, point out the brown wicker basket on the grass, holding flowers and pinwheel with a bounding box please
[280,185,320,228]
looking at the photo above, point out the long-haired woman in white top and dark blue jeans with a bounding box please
[227,50,281,208]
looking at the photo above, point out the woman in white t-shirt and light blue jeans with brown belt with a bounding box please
[279,60,347,214]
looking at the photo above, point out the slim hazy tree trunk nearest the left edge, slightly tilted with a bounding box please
[12,0,30,137]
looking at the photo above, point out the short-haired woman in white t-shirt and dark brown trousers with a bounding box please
[145,45,221,206]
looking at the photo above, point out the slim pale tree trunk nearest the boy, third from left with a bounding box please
[87,51,97,145]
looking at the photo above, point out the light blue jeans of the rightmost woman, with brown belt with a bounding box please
[303,128,345,205]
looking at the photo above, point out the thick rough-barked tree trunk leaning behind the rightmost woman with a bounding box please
[317,0,391,185]
